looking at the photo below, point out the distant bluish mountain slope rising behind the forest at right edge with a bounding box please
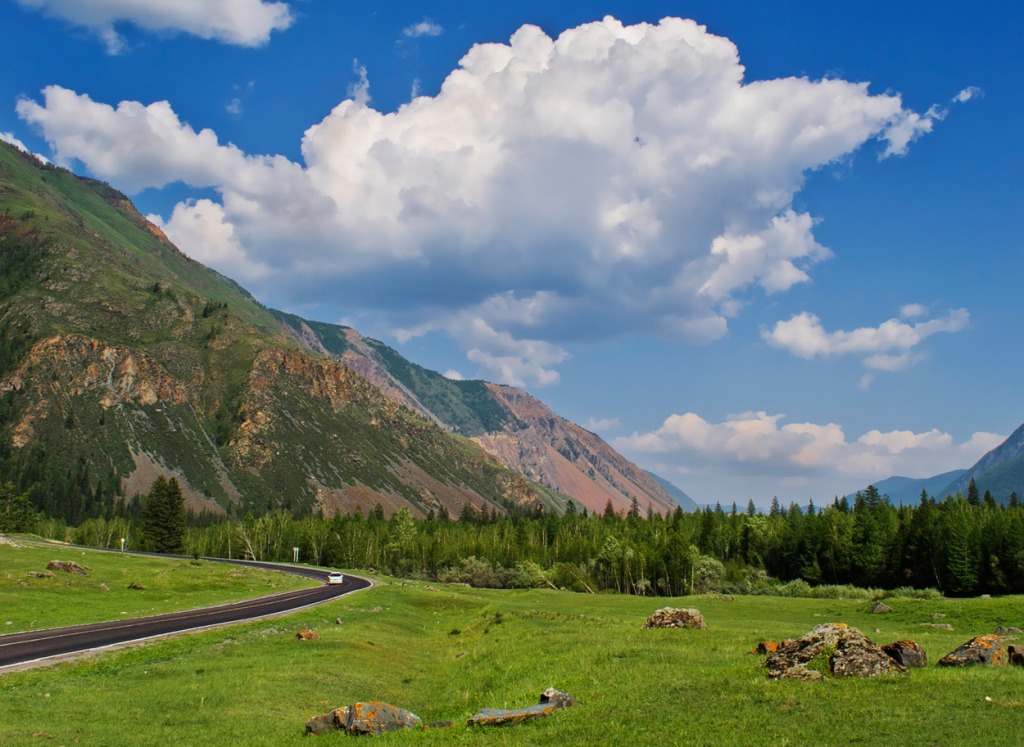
[847,424,1024,505]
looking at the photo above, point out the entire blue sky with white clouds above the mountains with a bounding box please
[0,0,1024,505]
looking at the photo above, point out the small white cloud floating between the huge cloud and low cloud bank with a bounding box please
[762,304,971,370]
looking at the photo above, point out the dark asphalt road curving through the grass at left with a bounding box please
[0,558,372,671]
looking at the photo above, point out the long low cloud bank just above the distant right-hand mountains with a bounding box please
[612,412,1006,502]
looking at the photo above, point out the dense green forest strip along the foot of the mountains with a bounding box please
[0,485,1024,595]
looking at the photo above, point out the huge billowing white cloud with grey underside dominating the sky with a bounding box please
[17,17,935,382]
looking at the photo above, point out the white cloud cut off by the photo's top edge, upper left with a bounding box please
[17,0,293,54]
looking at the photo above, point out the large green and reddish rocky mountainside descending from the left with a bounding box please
[0,142,685,522]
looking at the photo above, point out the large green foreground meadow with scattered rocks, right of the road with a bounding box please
[0,541,1024,747]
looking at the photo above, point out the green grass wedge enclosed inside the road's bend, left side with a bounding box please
[0,540,315,634]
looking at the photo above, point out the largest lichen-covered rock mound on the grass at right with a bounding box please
[765,623,906,680]
